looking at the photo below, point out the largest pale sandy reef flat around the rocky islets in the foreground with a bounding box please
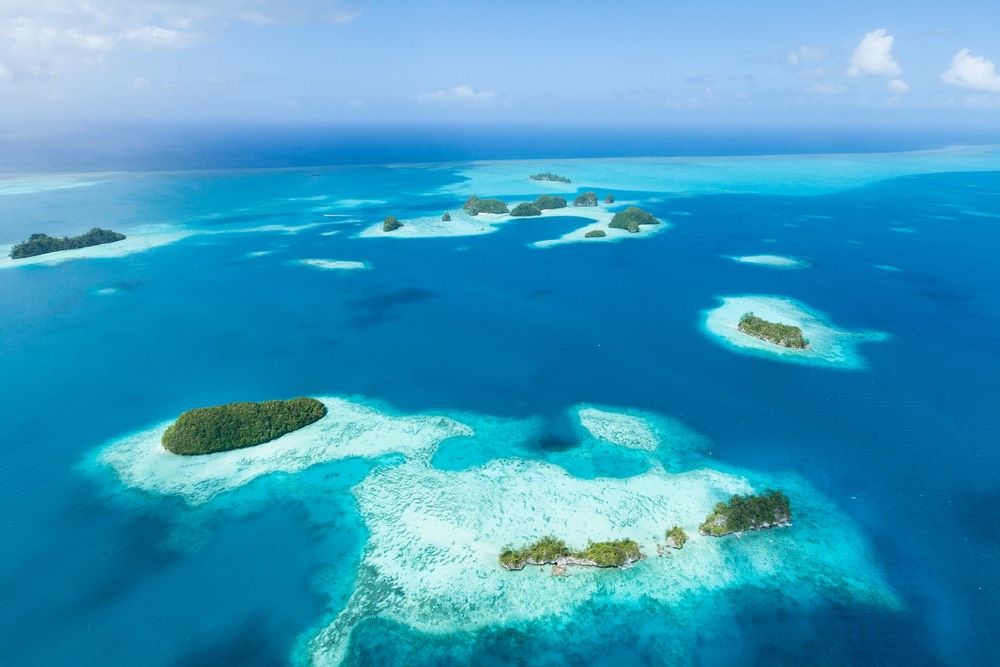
[302,459,898,665]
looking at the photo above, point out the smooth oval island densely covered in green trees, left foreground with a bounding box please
[161,397,326,456]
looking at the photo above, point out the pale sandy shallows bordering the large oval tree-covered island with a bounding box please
[96,398,472,505]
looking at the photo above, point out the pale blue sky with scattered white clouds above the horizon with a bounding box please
[0,0,1000,128]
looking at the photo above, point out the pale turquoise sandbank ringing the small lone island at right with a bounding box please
[702,295,888,369]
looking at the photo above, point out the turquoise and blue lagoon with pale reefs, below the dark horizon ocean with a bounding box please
[0,133,1000,665]
